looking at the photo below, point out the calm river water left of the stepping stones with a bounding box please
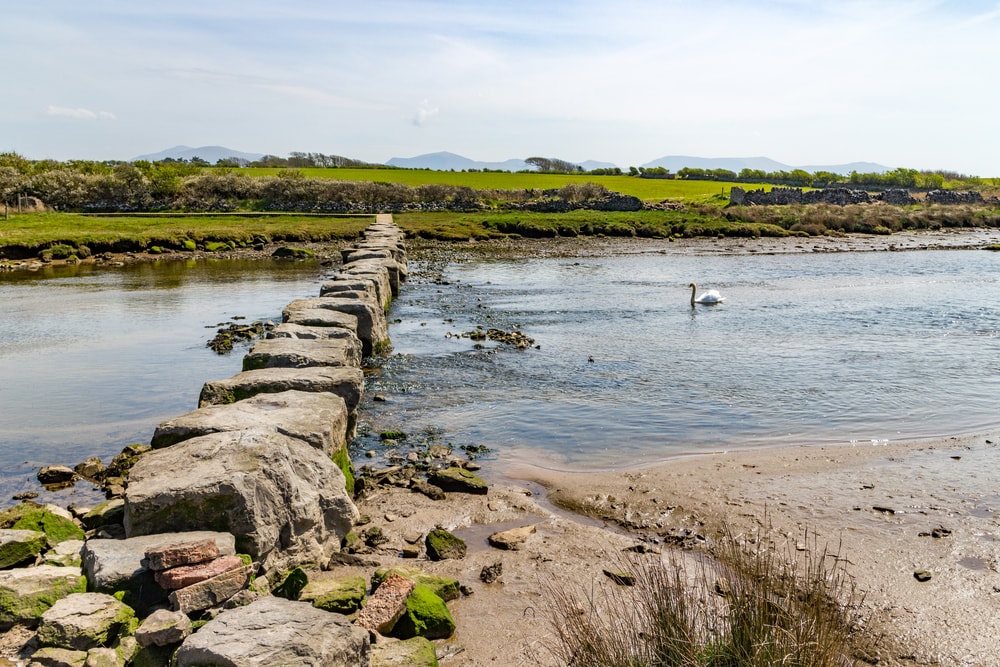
[0,260,334,503]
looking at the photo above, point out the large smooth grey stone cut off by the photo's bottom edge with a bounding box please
[175,597,371,667]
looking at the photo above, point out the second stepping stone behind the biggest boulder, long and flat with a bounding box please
[199,366,365,414]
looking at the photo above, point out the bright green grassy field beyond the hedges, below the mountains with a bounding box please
[234,168,756,203]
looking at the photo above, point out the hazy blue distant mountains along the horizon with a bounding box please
[132,146,890,175]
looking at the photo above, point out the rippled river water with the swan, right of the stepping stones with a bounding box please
[368,250,1000,469]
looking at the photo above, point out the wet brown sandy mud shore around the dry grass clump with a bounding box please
[359,433,1000,667]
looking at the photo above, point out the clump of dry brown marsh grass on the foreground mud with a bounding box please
[548,530,862,667]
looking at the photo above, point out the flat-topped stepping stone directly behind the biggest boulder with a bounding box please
[151,390,350,456]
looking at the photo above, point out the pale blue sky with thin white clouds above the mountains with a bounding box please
[0,0,1000,177]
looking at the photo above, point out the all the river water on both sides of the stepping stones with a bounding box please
[0,245,1000,504]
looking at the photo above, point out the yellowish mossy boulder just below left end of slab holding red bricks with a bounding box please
[38,593,135,651]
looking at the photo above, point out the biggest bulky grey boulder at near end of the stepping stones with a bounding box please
[125,431,358,571]
